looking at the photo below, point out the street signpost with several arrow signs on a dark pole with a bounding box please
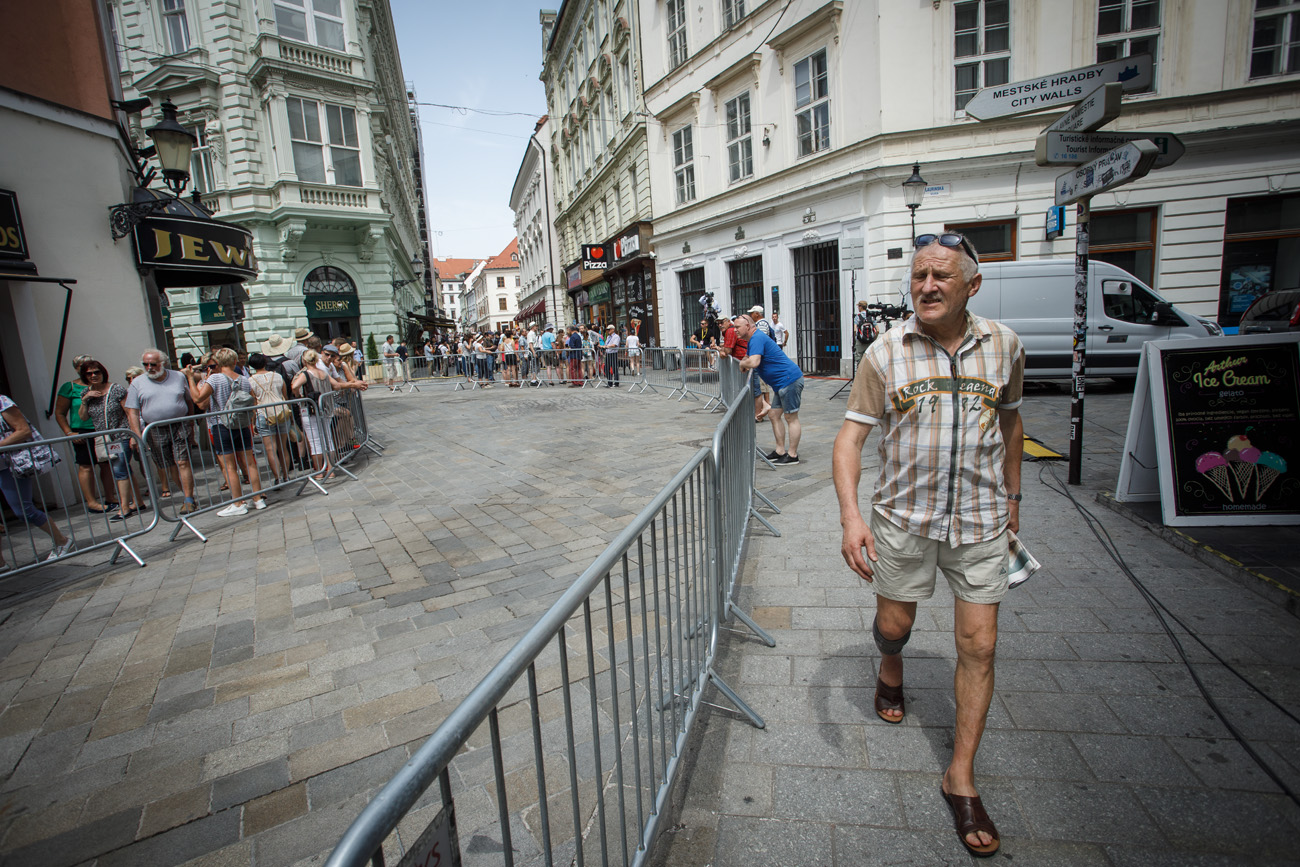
[966,55,1186,485]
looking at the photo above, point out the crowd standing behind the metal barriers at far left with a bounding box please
[0,328,368,569]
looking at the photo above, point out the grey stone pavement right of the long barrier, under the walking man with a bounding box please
[654,383,1300,867]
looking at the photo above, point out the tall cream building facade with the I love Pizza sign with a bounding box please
[541,0,662,342]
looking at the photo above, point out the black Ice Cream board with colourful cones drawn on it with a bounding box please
[1152,334,1300,524]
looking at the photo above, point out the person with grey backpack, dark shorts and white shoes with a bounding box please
[186,348,267,517]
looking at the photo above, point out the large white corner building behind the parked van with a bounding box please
[640,0,1300,373]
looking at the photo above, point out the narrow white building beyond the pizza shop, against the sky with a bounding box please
[510,117,575,326]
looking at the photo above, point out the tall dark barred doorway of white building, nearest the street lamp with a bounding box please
[794,240,841,376]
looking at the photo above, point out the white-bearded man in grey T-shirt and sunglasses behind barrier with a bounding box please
[122,350,199,515]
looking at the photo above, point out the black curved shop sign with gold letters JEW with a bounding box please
[135,216,257,289]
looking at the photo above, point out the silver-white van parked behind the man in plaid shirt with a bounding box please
[967,259,1223,380]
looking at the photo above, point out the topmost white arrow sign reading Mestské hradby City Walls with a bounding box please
[966,55,1152,121]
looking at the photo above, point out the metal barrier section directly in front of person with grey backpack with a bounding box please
[142,390,332,542]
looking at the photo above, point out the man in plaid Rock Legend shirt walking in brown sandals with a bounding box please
[833,234,1024,855]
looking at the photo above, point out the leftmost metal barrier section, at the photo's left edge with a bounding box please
[0,428,159,577]
